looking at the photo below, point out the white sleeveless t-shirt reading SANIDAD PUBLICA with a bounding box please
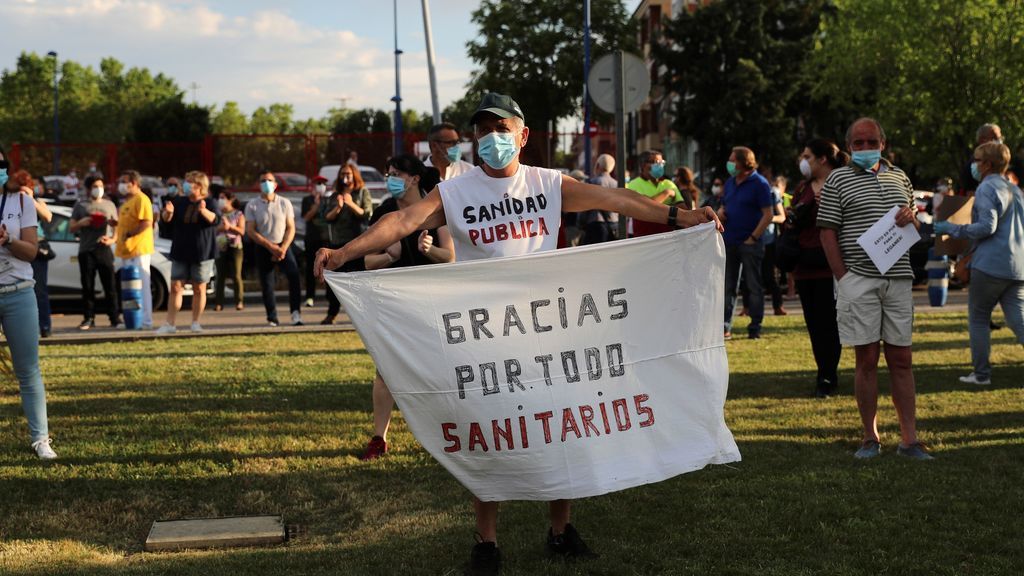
[437,164,562,261]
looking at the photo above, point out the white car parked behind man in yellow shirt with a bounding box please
[39,204,214,310]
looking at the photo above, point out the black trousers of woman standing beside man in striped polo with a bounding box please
[797,278,843,392]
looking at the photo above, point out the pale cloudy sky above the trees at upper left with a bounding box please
[0,0,469,118]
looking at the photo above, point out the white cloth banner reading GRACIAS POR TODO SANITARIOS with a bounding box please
[327,224,739,501]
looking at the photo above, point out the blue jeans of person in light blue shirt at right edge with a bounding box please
[967,269,1024,380]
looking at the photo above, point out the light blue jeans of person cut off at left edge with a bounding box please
[0,288,49,442]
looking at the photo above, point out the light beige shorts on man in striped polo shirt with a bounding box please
[836,272,913,346]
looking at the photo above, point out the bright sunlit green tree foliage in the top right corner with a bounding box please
[810,0,1024,180]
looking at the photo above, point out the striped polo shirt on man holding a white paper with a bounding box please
[817,160,913,278]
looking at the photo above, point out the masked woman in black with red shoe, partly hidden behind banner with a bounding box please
[362,154,455,460]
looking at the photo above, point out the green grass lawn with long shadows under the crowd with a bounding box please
[0,315,1024,576]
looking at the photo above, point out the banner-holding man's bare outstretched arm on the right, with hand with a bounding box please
[562,175,723,232]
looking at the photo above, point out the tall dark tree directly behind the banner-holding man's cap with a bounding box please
[466,0,636,160]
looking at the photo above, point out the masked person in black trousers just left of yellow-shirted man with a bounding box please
[70,174,121,330]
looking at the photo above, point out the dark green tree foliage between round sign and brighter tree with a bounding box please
[653,0,823,173]
